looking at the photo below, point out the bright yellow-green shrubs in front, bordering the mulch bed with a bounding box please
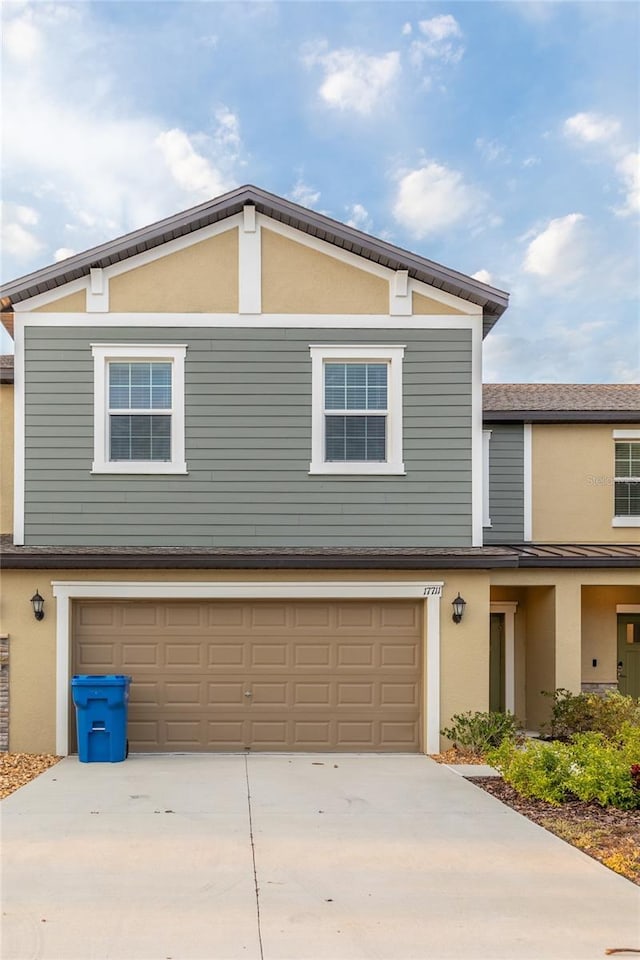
[487,721,640,810]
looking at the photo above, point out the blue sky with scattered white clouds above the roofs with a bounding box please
[2,0,640,382]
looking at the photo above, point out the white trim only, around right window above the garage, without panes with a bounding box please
[309,344,405,476]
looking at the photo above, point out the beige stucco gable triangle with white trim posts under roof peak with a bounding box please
[22,217,482,323]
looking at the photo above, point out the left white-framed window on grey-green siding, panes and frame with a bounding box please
[91,343,187,474]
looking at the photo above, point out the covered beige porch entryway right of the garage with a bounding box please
[489,567,640,731]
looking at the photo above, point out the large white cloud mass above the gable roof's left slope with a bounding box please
[3,4,243,275]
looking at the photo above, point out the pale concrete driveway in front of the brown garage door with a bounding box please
[1,754,640,960]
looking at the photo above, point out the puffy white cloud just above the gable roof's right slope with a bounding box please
[393,161,484,238]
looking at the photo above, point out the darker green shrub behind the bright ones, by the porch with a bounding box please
[542,687,640,740]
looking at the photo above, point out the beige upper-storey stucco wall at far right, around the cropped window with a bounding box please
[532,423,640,543]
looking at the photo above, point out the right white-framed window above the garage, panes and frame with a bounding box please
[309,345,405,474]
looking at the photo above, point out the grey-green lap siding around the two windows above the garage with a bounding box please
[25,327,471,547]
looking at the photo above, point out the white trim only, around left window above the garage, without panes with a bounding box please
[91,343,187,474]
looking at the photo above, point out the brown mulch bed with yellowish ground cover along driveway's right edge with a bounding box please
[467,777,640,885]
